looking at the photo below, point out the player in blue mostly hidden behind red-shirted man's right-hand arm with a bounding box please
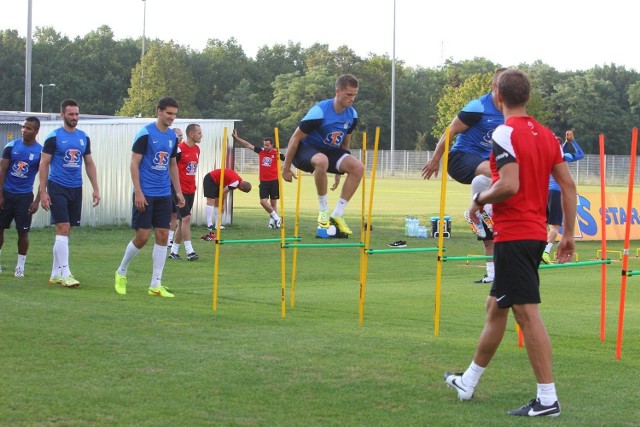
[542,130,584,264]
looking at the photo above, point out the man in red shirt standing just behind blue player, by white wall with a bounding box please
[169,123,202,261]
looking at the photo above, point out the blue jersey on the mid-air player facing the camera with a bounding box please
[300,98,358,149]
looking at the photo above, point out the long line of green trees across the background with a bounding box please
[0,25,640,154]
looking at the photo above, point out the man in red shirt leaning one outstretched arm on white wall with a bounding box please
[232,129,284,228]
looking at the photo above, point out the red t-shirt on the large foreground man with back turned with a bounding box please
[489,116,563,242]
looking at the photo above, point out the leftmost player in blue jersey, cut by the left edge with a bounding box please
[0,116,42,277]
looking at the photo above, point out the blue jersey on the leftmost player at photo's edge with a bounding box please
[2,139,42,194]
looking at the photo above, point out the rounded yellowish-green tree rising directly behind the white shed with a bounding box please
[118,43,201,118]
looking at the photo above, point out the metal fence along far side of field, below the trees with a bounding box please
[235,148,640,186]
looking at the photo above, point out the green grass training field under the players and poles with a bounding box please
[0,176,640,426]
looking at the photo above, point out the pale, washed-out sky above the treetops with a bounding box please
[0,0,640,71]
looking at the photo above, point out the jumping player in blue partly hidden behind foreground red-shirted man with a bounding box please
[422,68,506,283]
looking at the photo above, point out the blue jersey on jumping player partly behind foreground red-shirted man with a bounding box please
[451,93,504,160]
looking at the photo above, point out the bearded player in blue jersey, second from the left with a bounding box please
[39,99,100,288]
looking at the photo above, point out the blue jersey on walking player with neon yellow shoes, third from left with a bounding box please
[131,122,178,197]
